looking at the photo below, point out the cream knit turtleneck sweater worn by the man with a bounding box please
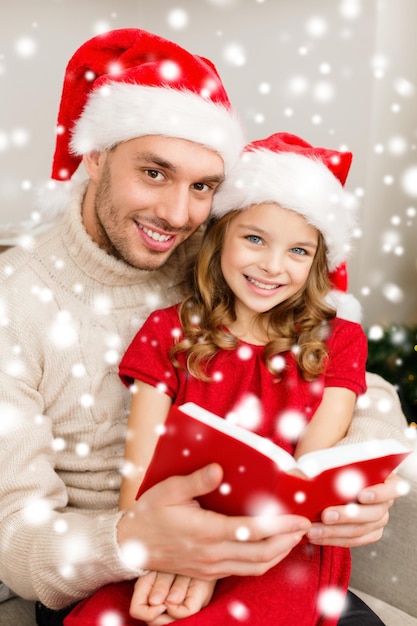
[0,187,405,608]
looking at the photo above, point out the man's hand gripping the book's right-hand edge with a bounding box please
[307,474,408,548]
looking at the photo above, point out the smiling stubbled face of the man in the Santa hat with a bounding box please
[83,135,224,270]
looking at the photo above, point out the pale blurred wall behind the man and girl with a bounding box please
[0,0,417,330]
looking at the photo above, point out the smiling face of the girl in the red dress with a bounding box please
[221,202,318,321]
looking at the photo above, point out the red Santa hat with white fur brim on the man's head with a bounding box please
[43,28,245,214]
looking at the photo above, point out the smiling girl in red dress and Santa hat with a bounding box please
[66,133,367,626]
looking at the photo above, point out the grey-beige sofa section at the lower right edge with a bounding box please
[351,455,417,617]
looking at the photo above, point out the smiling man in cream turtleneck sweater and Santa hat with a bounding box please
[0,29,410,624]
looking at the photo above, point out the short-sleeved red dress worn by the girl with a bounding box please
[64,307,367,626]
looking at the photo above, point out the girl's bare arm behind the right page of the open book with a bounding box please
[294,387,356,459]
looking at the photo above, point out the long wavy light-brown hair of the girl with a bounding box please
[170,210,336,381]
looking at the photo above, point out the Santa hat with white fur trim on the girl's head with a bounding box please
[211,133,361,322]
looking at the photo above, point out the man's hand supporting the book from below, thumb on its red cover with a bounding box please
[118,464,311,580]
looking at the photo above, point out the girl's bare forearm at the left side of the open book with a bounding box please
[119,380,172,509]
